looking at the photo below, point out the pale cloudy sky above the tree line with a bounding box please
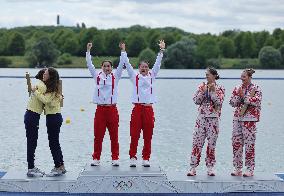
[0,0,284,34]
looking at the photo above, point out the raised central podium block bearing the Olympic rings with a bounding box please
[67,164,175,193]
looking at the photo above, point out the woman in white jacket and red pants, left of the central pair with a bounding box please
[86,43,126,166]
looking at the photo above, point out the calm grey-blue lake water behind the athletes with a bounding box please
[0,69,284,174]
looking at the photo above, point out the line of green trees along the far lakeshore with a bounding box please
[0,25,284,69]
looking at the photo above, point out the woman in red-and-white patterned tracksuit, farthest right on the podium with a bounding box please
[230,69,262,177]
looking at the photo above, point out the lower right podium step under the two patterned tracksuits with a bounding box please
[167,172,284,193]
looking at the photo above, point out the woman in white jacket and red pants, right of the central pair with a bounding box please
[121,40,165,167]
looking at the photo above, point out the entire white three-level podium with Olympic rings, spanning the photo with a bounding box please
[0,164,284,193]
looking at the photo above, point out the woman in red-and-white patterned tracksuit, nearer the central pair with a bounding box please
[187,68,225,176]
